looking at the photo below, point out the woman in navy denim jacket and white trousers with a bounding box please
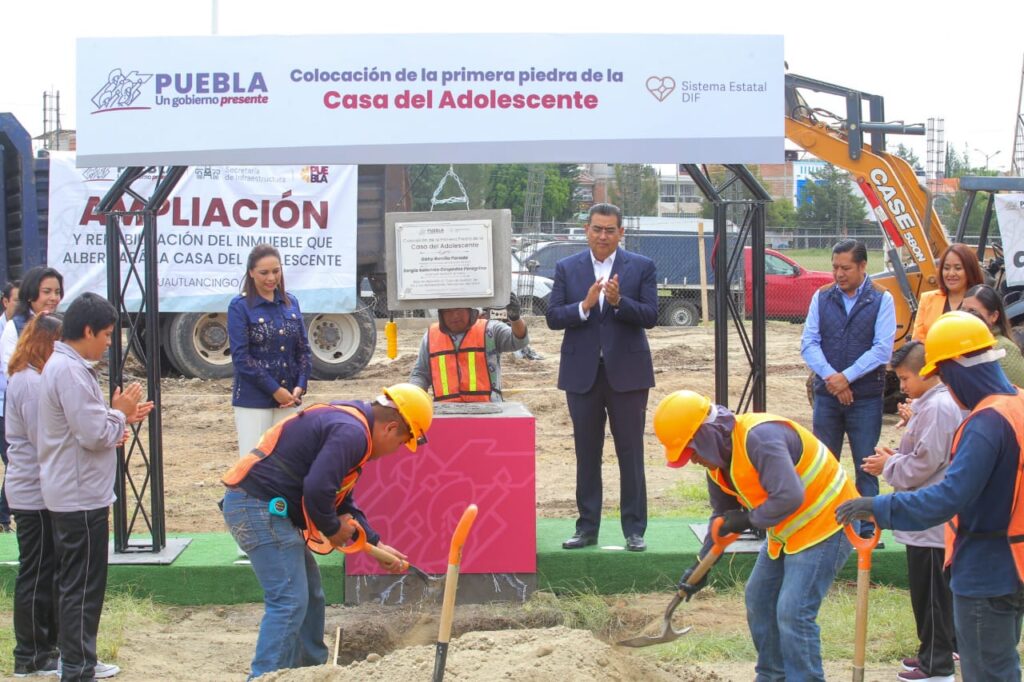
[227,244,312,457]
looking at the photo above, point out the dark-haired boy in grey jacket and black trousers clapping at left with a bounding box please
[37,293,153,681]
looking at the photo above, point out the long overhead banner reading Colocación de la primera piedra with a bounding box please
[77,34,783,166]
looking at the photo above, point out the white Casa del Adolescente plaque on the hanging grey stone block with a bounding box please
[395,220,495,301]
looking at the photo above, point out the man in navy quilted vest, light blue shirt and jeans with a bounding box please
[800,240,896,536]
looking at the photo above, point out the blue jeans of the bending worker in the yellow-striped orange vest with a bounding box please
[746,531,853,682]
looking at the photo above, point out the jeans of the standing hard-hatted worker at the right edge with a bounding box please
[953,590,1024,682]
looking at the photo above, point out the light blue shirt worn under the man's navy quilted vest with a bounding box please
[800,278,896,384]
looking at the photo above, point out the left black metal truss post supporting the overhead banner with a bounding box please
[96,166,187,554]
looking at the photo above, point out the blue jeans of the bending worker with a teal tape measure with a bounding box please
[224,489,328,679]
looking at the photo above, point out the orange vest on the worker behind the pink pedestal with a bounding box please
[427,319,492,402]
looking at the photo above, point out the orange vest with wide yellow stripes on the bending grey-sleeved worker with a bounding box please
[708,414,858,559]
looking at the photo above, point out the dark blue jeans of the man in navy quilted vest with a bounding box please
[813,393,883,535]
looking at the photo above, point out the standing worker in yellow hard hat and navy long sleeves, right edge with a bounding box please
[836,310,1024,682]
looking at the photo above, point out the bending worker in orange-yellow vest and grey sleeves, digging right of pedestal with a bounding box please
[654,390,857,680]
